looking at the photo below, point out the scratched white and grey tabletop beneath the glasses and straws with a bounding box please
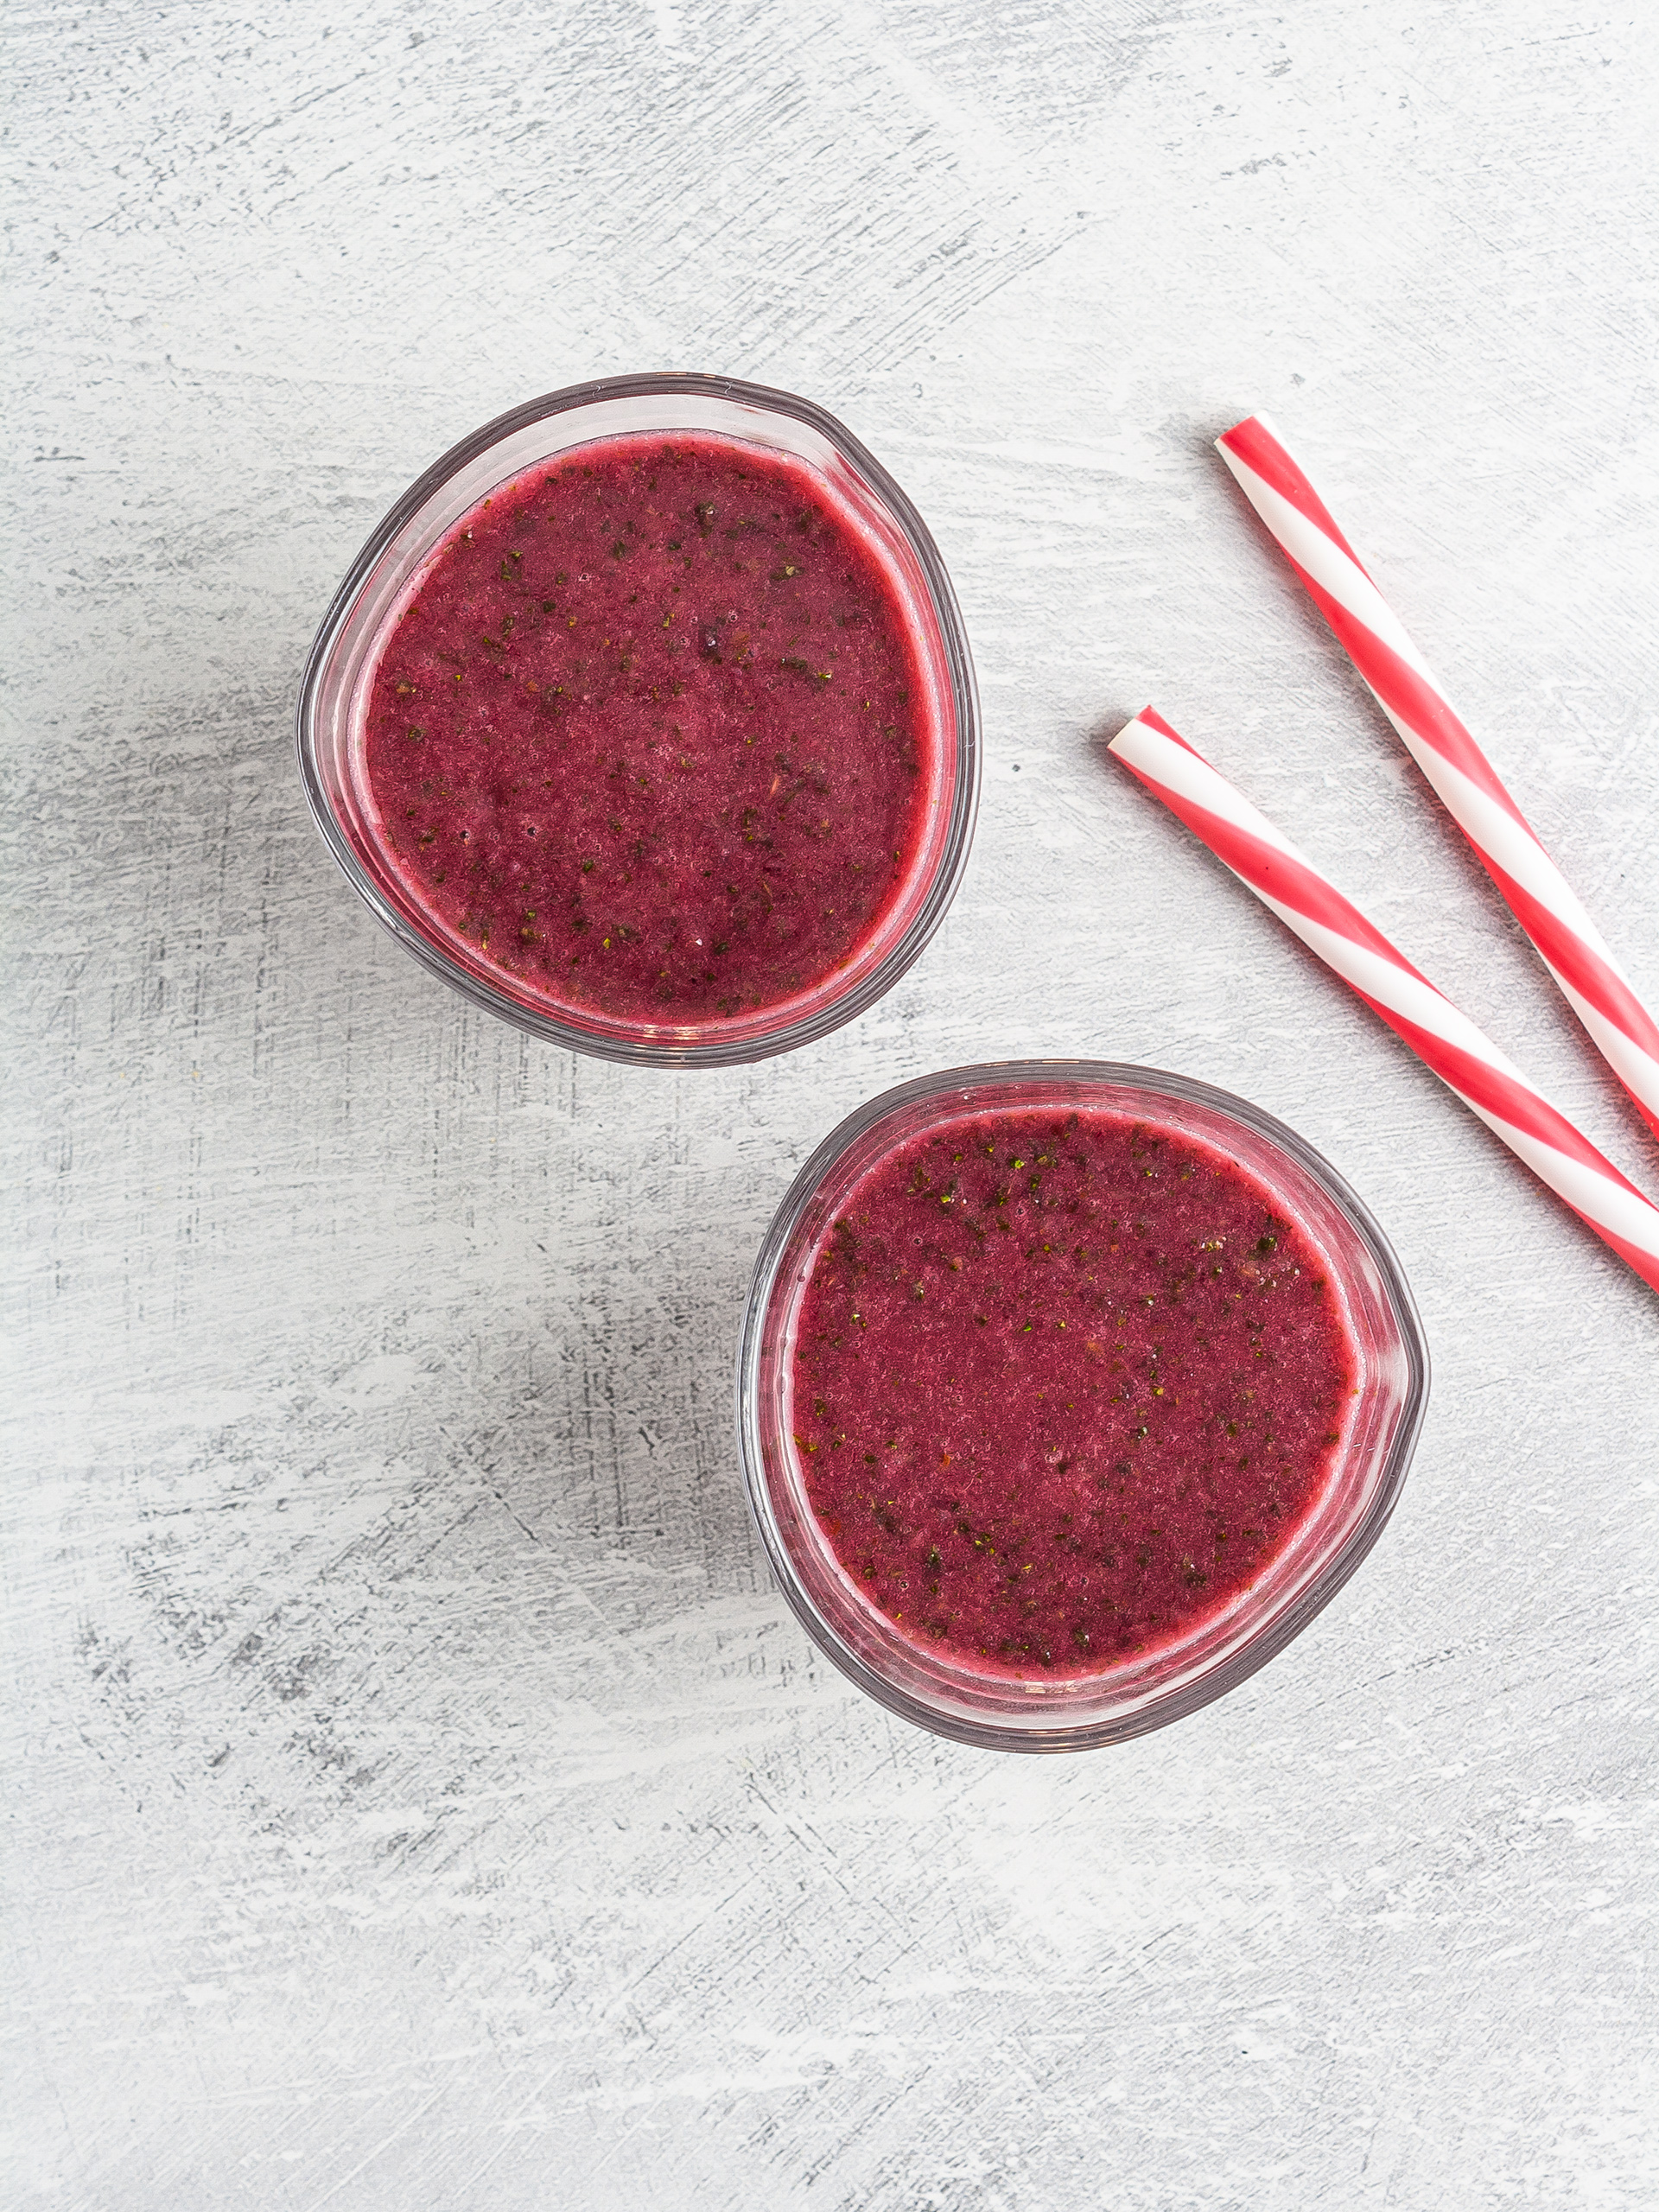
[0,0,1659,2212]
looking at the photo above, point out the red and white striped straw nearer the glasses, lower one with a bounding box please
[1110,706,1659,1289]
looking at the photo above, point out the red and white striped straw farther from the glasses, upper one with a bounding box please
[1217,416,1659,1137]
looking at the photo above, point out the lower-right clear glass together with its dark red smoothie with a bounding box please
[739,1062,1427,1750]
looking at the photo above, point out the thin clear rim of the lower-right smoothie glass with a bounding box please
[736,1059,1431,1752]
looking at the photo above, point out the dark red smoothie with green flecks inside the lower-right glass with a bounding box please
[790,1109,1356,1679]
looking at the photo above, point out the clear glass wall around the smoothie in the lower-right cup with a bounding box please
[736,1059,1429,1752]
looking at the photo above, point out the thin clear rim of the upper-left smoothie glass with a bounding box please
[294,370,982,1068]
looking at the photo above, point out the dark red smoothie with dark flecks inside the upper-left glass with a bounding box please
[363,431,940,1027]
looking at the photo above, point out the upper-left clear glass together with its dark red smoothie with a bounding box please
[299,376,978,1064]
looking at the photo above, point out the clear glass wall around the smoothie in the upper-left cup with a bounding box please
[296,374,980,1068]
